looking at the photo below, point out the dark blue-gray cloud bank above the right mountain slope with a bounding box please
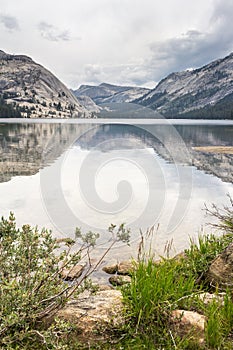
[146,0,233,81]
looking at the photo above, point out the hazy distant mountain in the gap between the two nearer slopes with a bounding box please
[73,83,149,105]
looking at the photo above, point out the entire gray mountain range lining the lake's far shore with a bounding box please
[0,50,233,119]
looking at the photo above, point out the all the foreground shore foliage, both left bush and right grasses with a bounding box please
[0,199,233,350]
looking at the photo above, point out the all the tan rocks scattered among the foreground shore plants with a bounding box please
[57,243,233,346]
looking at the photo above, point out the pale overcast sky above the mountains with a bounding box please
[0,0,233,88]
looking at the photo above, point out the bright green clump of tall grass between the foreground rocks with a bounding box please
[123,257,198,349]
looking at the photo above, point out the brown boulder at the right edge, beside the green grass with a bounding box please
[207,243,233,290]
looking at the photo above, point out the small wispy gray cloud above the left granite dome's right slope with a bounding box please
[38,22,71,41]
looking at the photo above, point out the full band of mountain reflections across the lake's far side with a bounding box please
[0,123,233,183]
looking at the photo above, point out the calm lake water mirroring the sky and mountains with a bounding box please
[0,119,233,258]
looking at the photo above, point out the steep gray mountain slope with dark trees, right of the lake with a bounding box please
[134,53,233,119]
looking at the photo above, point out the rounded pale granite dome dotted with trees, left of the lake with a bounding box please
[0,50,92,118]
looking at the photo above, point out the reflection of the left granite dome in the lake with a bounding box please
[0,123,94,182]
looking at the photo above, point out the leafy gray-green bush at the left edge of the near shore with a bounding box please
[0,214,81,348]
